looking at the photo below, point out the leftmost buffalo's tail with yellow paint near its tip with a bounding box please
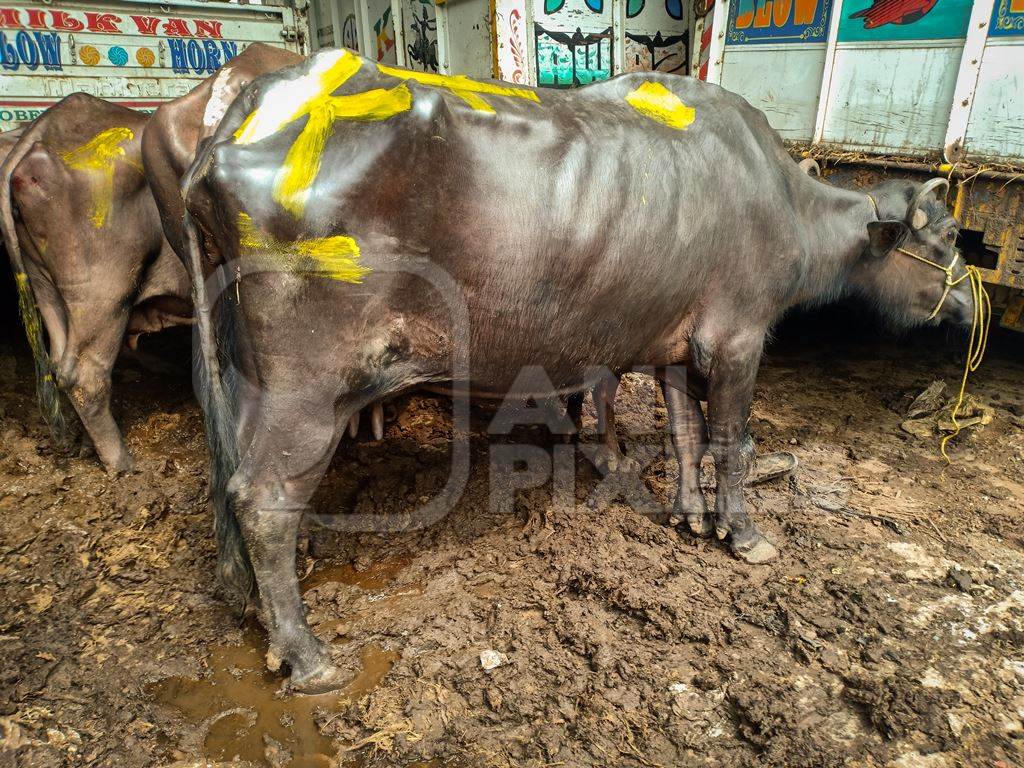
[0,118,71,446]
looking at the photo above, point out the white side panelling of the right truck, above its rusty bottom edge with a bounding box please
[708,0,1024,165]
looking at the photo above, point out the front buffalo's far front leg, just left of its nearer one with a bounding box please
[662,381,715,536]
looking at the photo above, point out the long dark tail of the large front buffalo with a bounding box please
[181,150,256,611]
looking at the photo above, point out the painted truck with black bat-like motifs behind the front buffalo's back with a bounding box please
[309,0,692,81]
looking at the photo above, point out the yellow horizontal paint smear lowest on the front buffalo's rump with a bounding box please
[239,213,372,283]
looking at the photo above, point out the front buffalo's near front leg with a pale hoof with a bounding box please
[708,334,778,563]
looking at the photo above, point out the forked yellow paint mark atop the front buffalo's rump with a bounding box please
[234,50,413,218]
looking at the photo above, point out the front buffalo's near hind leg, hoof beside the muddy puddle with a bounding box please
[228,393,354,693]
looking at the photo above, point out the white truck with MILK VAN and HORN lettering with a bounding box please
[0,0,306,130]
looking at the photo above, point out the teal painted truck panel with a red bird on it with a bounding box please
[839,0,972,43]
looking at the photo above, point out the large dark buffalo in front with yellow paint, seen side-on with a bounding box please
[183,50,972,691]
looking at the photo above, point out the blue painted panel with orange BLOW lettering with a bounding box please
[725,0,831,45]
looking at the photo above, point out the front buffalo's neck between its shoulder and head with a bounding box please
[793,182,876,313]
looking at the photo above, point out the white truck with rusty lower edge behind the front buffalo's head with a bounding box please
[695,0,1024,330]
